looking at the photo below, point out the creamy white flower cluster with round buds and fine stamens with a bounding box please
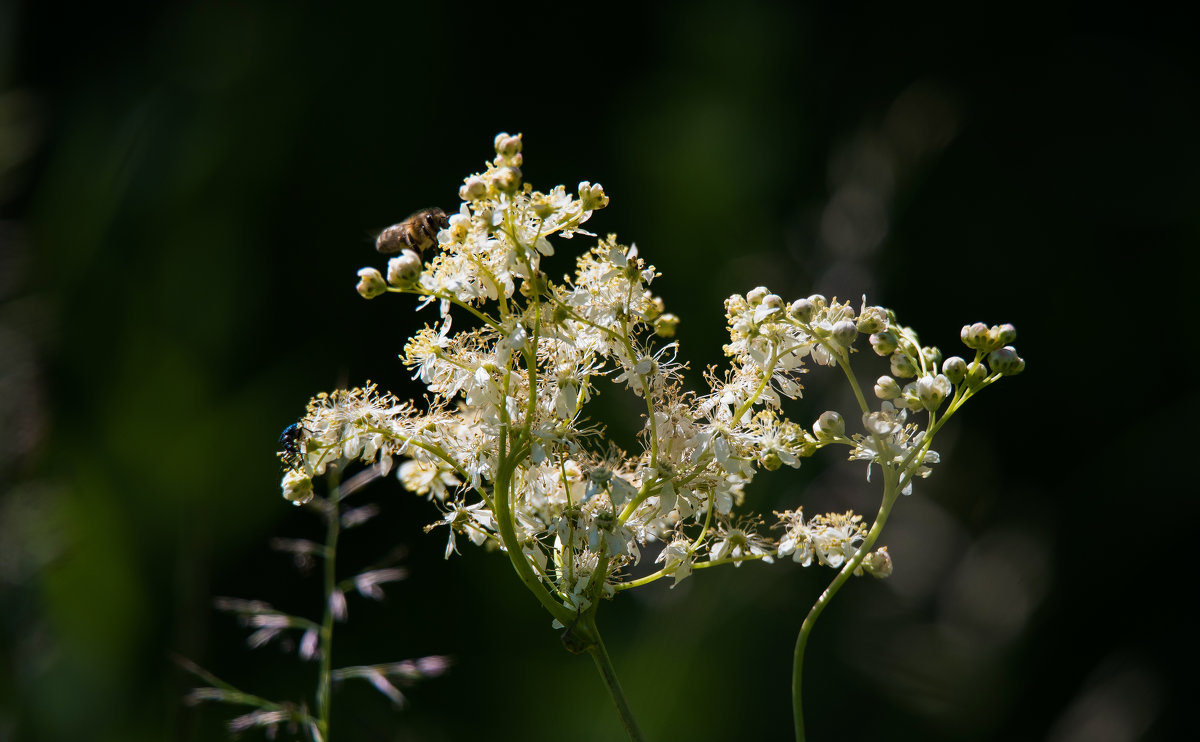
[283,133,1019,612]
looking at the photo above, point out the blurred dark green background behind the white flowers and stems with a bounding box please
[0,1,1200,742]
